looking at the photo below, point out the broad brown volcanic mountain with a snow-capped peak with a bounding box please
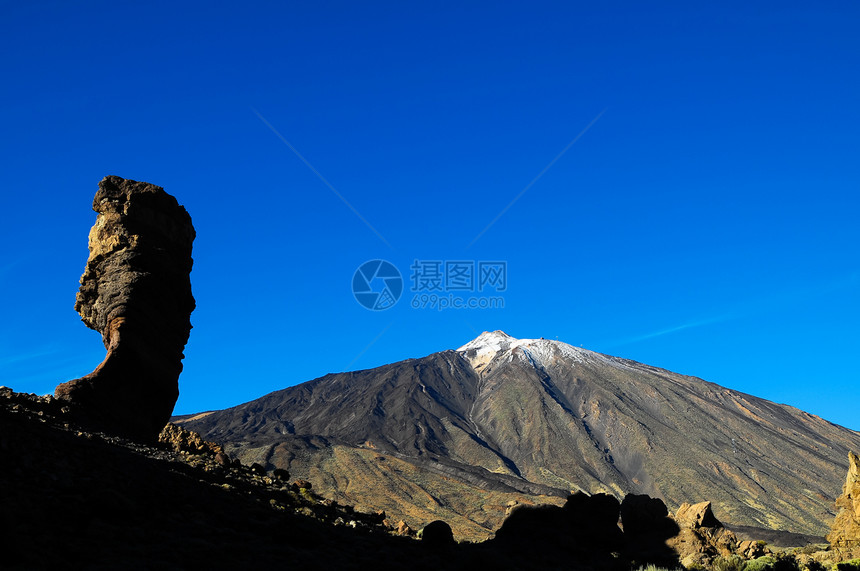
[176,331,860,539]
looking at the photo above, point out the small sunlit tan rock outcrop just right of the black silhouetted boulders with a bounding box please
[668,502,744,568]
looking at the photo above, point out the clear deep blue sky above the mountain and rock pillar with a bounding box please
[0,0,860,429]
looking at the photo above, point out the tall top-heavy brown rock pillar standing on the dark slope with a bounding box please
[55,176,195,441]
